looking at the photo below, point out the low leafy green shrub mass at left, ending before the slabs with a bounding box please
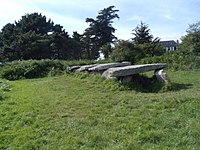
[0,60,64,80]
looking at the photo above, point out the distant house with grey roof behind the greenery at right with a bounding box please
[159,40,179,52]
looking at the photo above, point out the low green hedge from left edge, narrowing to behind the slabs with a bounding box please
[0,60,94,80]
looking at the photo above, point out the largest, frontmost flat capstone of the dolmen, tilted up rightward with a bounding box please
[102,63,168,78]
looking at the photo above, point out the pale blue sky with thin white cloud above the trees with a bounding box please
[0,0,200,41]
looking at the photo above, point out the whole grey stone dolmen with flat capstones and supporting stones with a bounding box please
[68,62,170,83]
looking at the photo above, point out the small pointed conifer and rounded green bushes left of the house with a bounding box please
[111,22,165,63]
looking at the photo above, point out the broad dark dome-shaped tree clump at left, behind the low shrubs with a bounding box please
[0,13,81,61]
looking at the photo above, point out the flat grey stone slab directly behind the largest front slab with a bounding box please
[88,62,131,72]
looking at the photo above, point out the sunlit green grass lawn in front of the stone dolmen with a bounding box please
[0,70,200,150]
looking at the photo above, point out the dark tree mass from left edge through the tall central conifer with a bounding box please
[0,6,119,61]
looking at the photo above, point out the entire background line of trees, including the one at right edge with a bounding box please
[0,6,200,62]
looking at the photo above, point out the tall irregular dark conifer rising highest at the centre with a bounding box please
[85,6,119,59]
